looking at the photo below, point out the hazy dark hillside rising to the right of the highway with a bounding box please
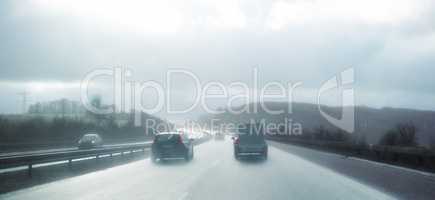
[199,102,435,146]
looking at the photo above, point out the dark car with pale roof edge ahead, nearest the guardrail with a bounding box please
[151,132,193,162]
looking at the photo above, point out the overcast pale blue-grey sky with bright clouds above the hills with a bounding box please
[0,0,435,116]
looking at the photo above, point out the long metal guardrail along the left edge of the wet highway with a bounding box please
[0,142,151,176]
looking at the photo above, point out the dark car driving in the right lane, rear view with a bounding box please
[233,128,268,159]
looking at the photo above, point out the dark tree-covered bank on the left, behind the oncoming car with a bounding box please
[0,114,172,144]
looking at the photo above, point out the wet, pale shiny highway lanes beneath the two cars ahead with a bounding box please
[0,139,410,200]
